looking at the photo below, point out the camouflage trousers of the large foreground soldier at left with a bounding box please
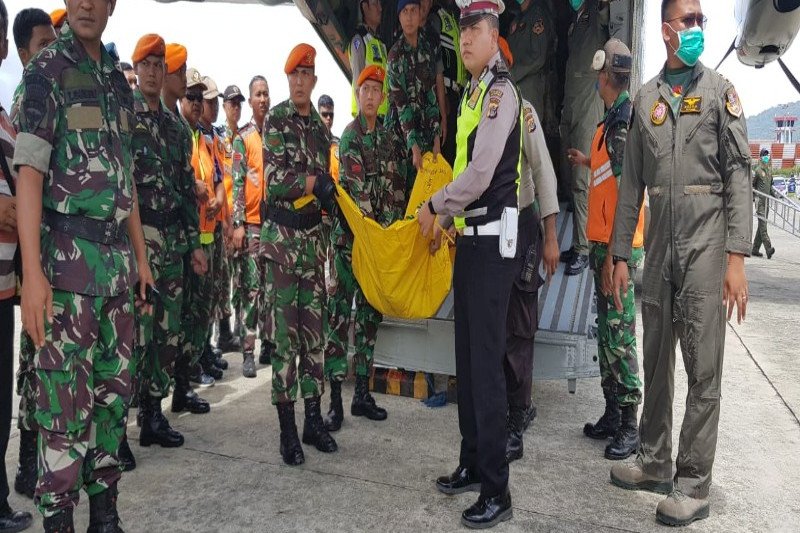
[35,290,134,516]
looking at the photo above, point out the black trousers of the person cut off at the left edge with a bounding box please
[0,299,14,505]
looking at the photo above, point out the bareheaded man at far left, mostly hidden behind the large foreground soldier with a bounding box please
[11,8,56,498]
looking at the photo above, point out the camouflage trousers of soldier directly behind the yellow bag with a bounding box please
[325,246,383,381]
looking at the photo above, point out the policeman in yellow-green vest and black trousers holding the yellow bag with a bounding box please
[418,0,521,528]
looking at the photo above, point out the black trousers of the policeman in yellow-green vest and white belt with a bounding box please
[453,237,521,497]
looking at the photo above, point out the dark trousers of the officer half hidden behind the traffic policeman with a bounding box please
[503,209,544,408]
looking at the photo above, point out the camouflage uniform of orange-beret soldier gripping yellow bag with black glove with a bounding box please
[261,100,330,405]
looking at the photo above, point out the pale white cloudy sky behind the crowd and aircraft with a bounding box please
[0,0,800,136]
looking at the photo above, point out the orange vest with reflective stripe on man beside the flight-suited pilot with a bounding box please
[586,124,644,248]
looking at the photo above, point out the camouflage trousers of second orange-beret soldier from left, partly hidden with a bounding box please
[179,240,216,368]
